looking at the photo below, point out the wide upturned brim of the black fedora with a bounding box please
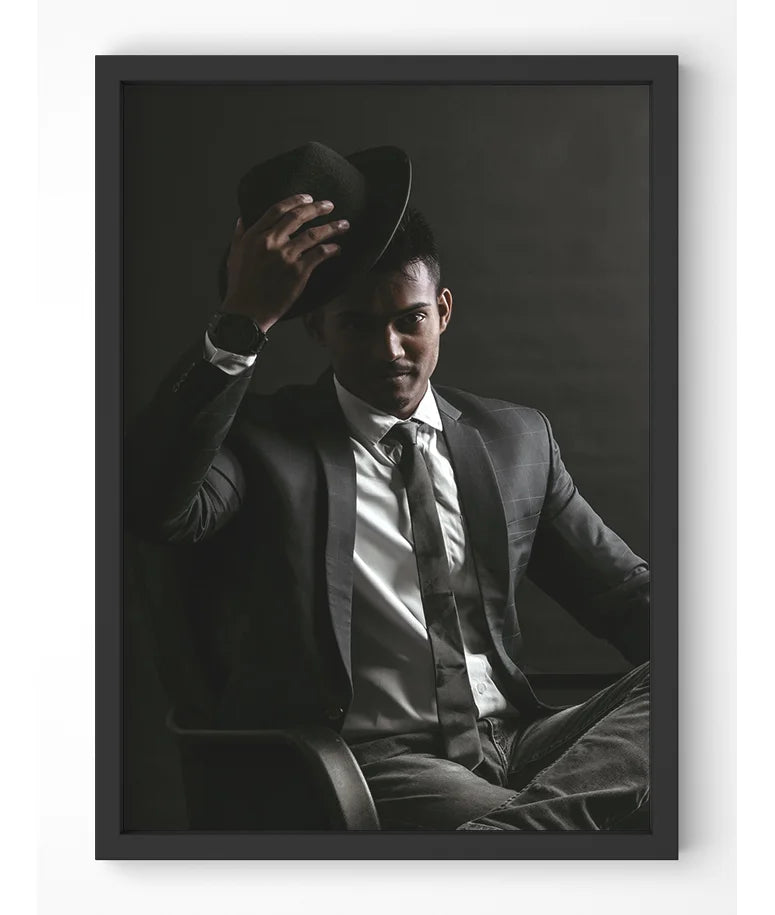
[219,146,412,320]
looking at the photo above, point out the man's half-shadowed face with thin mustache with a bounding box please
[306,263,452,419]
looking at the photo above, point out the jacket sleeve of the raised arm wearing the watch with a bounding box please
[123,341,253,542]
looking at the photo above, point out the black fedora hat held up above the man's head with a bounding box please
[218,141,412,320]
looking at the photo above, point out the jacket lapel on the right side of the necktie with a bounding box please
[433,390,509,654]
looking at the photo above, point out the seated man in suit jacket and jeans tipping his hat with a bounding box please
[125,144,649,830]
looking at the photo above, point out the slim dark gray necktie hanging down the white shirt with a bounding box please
[382,422,483,769]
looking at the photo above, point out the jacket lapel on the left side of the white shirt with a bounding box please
[306,371,356,679]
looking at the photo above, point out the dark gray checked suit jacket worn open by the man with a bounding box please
[124,344,649,727]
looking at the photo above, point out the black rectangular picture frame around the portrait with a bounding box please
[95,56,678,859]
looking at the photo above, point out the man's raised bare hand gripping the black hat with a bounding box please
[222,194,349,333]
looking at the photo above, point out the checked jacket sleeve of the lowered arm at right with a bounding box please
[527,414,650,664]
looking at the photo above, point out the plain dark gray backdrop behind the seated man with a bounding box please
[124,85,649,827]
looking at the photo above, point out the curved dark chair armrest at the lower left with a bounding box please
[167,710,380,830]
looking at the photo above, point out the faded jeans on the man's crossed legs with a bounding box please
[351,662,650,830]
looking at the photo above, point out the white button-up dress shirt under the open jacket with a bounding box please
[334,378,516,740]
